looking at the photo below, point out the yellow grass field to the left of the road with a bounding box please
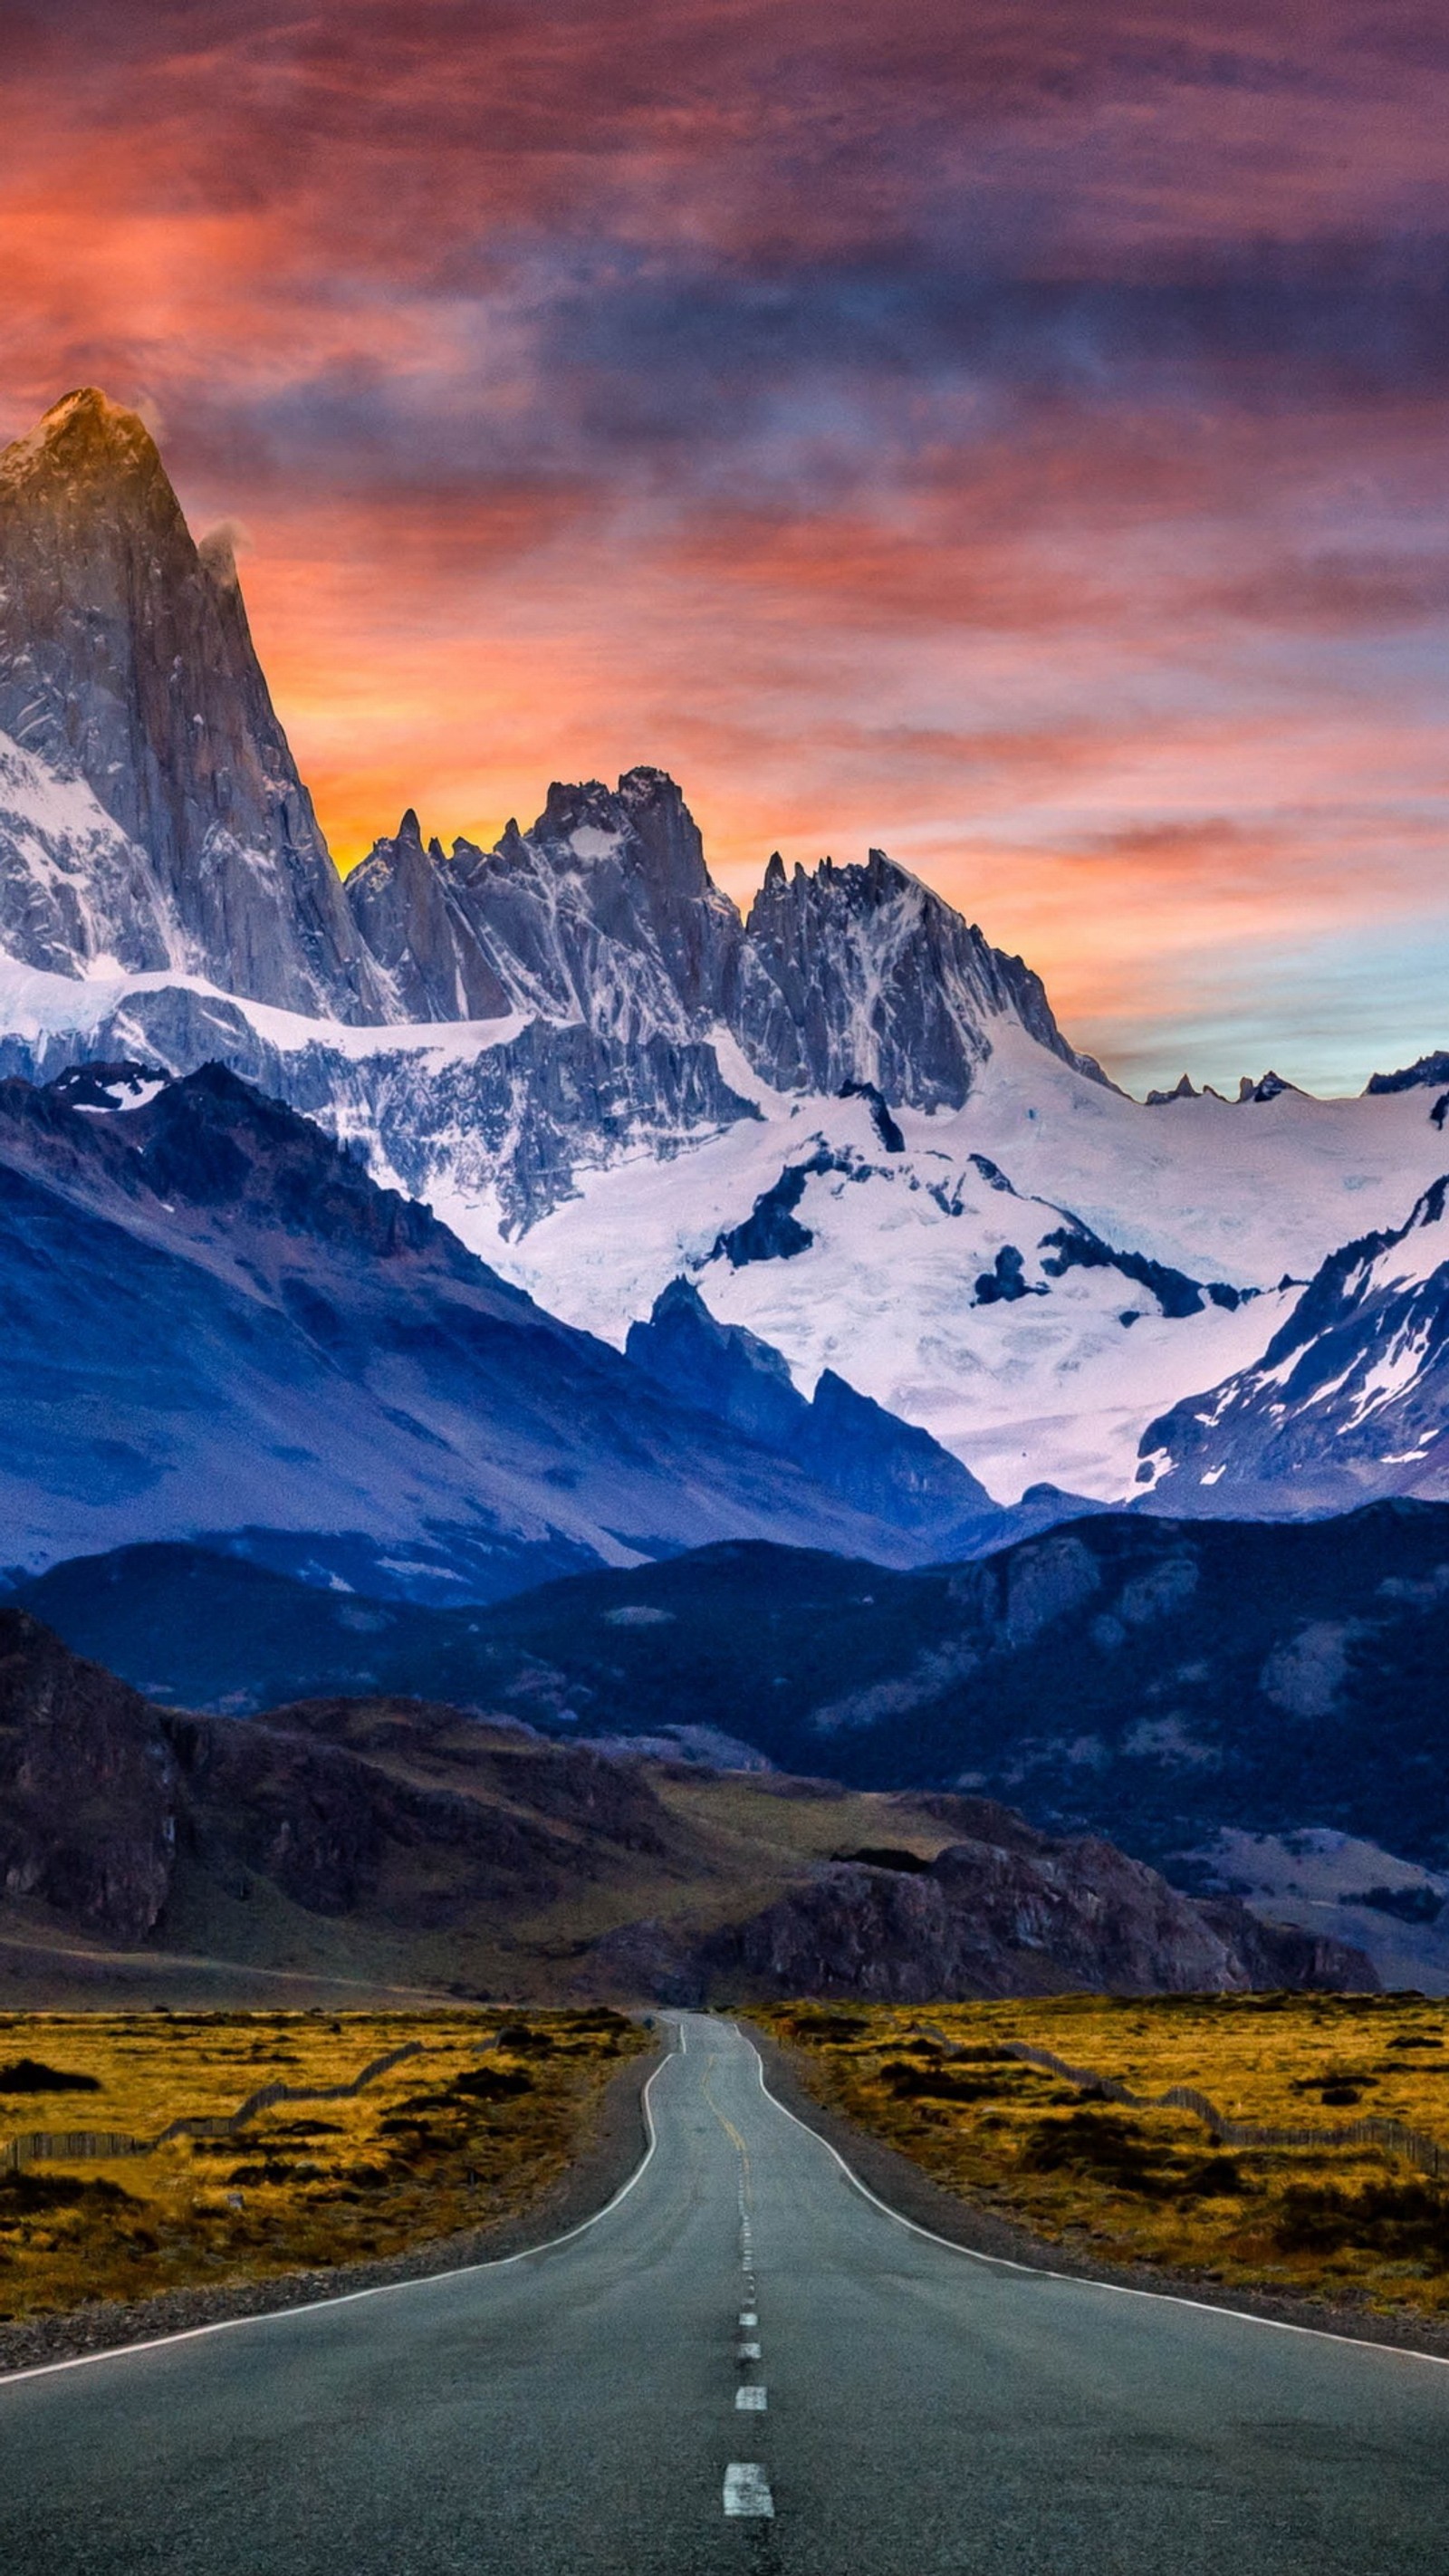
[0,2009,643,2319]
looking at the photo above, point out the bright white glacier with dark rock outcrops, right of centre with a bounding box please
[465,1031,1444,1502]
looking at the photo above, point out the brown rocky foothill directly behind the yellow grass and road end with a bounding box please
[0,1610,1372,2002]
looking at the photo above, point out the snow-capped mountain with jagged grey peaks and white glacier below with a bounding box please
[0,394,1449,1510]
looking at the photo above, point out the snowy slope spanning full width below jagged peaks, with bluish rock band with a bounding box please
[0,968,1449,1510]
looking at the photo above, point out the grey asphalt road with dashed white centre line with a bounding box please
[0,2017,1449,2576]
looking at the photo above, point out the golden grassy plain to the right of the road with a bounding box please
[757,1994,1449,2316]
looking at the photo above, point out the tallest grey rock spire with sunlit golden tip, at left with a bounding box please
[0,389,383,1017]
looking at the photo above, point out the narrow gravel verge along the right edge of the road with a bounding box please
[741,2014,1449,2360]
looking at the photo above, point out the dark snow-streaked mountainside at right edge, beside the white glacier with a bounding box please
[1137,1157,1449,1512]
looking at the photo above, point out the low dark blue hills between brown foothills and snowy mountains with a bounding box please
[13,1502,1449,1989]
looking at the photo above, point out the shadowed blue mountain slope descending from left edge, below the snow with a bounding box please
[0,1066,993,1600]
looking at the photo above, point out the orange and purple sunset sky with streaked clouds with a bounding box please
[0,0,1449,1090]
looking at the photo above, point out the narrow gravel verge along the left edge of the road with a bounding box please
[0,2033,664,2383]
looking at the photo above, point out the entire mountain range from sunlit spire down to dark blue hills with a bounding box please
[0,389,1449,1978]
